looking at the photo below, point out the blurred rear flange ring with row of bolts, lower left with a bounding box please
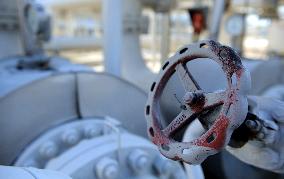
[14,118,111,168]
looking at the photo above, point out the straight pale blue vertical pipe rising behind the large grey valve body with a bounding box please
[103,0,123,76]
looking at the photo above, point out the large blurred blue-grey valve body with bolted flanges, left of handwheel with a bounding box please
[0,1,191,179]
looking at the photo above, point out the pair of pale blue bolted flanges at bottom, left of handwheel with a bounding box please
[15,117,186,179]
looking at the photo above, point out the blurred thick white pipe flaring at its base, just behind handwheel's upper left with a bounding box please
[119,0,155,91]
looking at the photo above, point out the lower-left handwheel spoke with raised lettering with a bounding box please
[163,110,193,137]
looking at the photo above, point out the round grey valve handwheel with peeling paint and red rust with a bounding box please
[146,40,250,164]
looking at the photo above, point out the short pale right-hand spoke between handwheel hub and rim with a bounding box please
[204,91,227,108]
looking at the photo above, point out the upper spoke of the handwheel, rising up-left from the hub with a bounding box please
[176,63,200,91]
